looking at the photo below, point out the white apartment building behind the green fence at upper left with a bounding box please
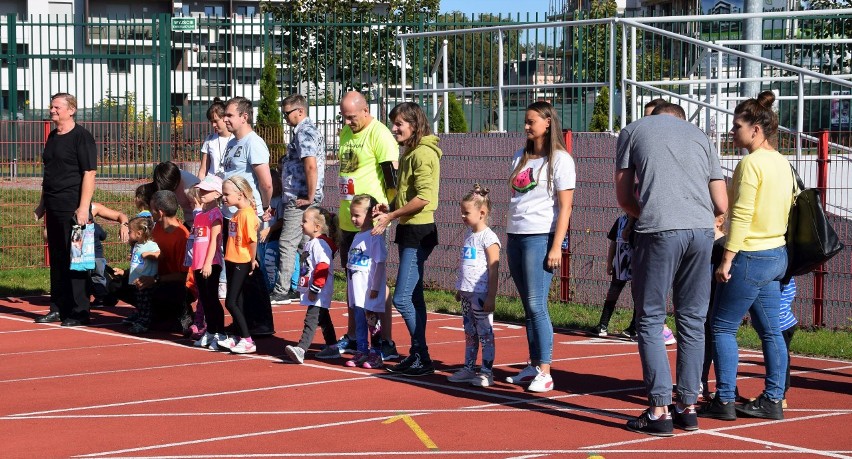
[0,0,283,114]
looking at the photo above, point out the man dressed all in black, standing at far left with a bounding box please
[33,93,97,327]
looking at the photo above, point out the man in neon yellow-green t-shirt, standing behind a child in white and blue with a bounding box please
[337,91,399,359]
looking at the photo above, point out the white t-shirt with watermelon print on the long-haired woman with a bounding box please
[506,149,577,234]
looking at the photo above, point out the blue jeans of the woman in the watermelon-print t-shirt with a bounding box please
[506,234,553,365]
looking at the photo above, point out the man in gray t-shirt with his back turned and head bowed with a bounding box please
[615,103,727,436]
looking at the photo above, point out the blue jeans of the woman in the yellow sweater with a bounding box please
[712,246,787,402]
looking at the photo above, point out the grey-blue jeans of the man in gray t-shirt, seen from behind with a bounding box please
[631,228,713,406]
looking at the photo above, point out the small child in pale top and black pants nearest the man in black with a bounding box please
[115,217,160,334]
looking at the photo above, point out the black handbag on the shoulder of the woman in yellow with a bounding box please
[784,164,843,281]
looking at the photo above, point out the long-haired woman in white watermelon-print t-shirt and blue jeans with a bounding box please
[506,102,576,392]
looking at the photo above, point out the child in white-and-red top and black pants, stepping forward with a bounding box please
[284,207,340,363]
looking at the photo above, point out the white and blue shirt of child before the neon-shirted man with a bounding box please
[346,231,388,312]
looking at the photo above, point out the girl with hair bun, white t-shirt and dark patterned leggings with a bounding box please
[447,183,500,387]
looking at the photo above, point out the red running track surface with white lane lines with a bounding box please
[0,298,852,459]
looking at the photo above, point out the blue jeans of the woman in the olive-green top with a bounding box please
[393,246,432,358]
